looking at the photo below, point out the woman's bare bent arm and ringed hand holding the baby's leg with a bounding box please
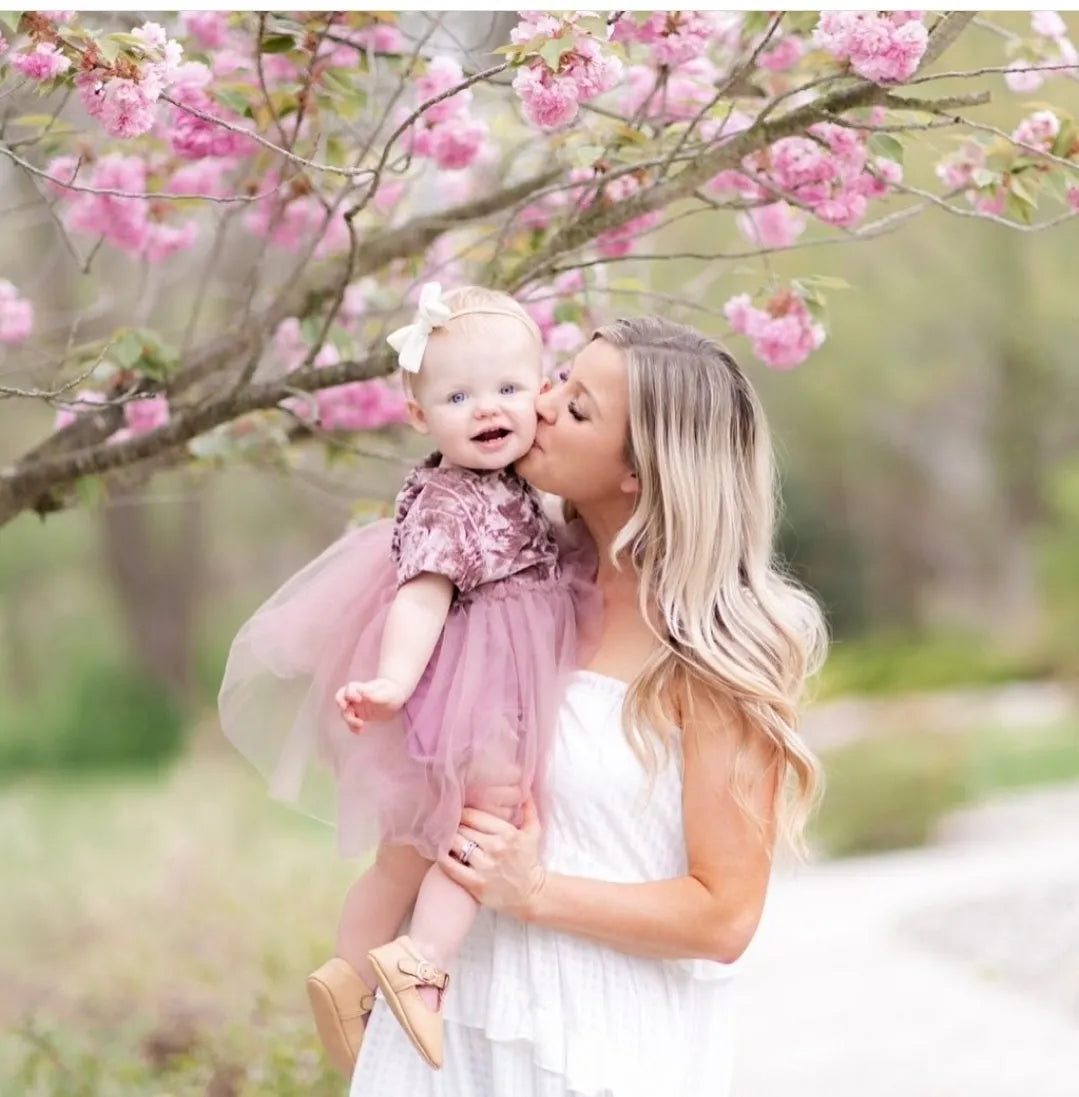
[442,697,777,963]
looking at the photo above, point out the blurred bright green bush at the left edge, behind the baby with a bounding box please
[0,657,188,777]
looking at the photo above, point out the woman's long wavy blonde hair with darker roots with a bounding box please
[593,317,827,852]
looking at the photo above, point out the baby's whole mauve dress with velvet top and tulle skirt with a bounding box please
[218,453,598,858]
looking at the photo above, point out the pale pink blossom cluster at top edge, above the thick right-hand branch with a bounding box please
[813,11,929,83]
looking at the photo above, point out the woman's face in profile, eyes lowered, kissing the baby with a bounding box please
[516,339,636,506]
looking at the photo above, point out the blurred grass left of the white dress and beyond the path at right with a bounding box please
[6,727,1079,1097]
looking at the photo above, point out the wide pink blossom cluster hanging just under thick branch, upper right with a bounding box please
[708,122,902,229]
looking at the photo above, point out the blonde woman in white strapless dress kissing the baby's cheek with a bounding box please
[351,317,824,1097]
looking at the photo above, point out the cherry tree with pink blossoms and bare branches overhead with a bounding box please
[0,11,1079,524]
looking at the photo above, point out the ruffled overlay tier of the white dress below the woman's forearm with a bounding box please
[436,912,736,1097]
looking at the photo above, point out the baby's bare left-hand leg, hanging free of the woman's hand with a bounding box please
[337,846,431,986]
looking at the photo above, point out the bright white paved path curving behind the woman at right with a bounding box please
[732,787,1079,1097]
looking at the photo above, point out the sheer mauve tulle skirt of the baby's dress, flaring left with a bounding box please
[218,520,598,858]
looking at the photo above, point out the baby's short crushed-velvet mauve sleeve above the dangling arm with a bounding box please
[395,484,486,593]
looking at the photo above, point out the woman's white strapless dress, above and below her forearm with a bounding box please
[350,670,737,1097]
